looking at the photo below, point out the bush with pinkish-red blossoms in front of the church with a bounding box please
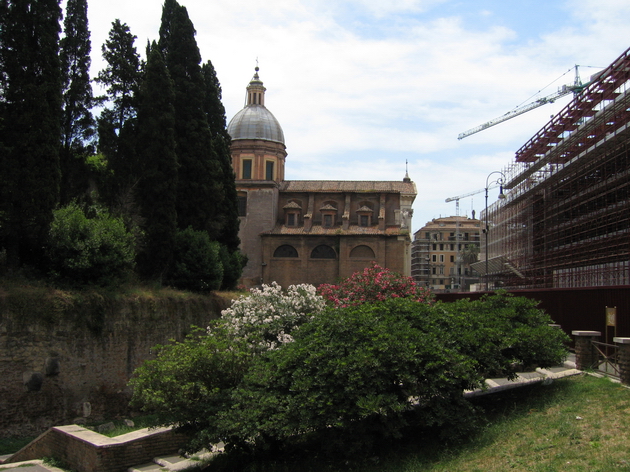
[317,262,432,308]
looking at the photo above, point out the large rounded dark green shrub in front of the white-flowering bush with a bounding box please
[219,299,483,449]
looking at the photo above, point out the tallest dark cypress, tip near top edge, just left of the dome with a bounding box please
[160,2,225,236]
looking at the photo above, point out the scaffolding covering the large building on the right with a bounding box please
[482,49,630,288]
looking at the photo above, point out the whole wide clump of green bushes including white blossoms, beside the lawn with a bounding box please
[132,292,568,458]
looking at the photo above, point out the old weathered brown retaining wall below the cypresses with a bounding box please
[0,288,228,437]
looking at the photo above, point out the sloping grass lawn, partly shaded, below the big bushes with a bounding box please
[207,375,630,472]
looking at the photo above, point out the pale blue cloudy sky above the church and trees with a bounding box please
[78,0,630,232]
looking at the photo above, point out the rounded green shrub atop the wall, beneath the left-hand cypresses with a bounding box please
[46,203,135,285]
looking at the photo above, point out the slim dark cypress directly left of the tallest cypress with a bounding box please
[135,43,177,279]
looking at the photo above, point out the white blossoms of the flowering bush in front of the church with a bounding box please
[216,282,326,350]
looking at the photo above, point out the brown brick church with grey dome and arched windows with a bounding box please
[228,67,417,287]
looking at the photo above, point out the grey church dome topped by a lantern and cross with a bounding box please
[227,67,285,144]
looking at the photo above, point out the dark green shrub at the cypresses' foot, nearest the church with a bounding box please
[166,227,223,292]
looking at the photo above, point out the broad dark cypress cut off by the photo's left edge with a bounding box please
[0,0,61,267]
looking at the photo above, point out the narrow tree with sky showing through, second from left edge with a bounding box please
[60,0,95,204]
